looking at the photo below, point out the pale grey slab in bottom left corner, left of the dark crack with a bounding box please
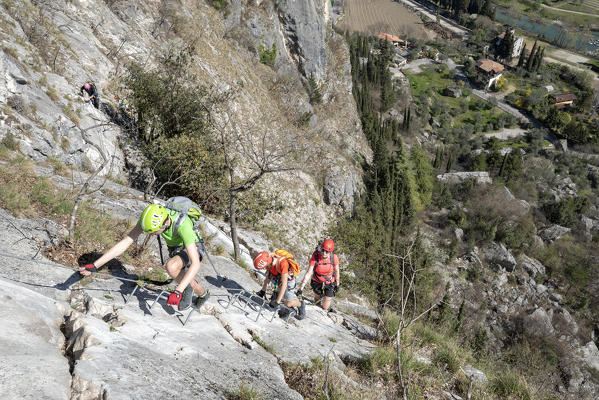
[0,278,71,399]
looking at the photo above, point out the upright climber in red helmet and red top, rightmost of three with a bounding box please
[297,239,340,311]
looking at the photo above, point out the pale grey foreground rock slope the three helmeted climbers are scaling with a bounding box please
[0,206,374,400]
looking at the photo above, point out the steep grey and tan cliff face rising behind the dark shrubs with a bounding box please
[0,0,372,252]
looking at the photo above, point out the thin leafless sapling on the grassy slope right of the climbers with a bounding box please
[385,240,437,400]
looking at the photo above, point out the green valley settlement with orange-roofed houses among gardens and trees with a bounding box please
[378,26,593,144]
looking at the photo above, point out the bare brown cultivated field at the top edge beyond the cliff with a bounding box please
[337,0,434,39]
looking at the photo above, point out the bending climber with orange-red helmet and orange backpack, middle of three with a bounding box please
[254,250,306,319]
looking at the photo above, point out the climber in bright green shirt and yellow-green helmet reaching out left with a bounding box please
[79,204,210,311]
